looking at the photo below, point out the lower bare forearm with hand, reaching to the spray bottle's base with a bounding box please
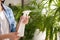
[0,32,18,40]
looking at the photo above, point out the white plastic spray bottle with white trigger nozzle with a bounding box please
[18,10,31,37]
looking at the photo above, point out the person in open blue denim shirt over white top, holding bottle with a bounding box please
[0,0,29,40]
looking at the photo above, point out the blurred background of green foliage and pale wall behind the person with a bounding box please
[4,0,60,40]
